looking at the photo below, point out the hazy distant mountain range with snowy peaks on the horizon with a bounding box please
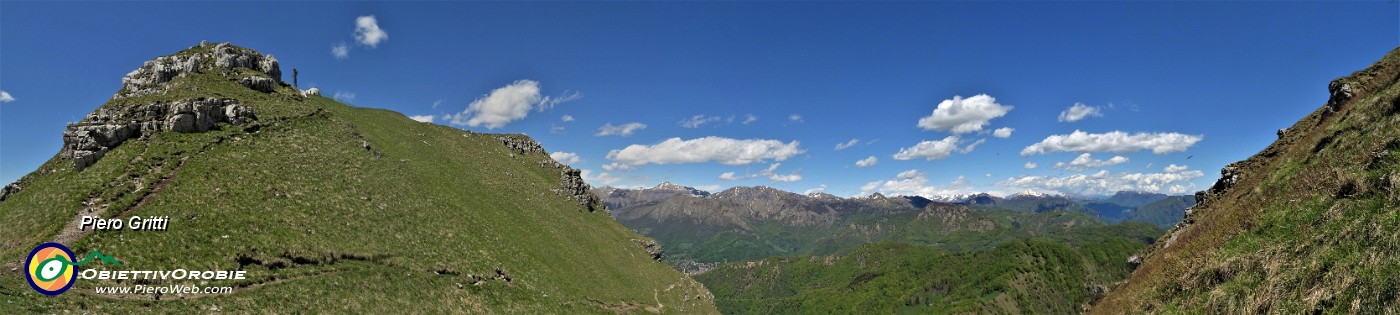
[594,182,1191,263]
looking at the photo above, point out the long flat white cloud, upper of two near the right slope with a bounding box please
[1021,130,1203,157]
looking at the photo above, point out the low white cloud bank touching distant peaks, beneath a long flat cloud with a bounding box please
[997,169,1205,195]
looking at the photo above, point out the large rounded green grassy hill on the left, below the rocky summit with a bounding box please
[0,45,715,314]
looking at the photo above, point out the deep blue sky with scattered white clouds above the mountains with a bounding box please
[0,1,1400,196]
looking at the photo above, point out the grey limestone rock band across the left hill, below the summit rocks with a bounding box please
[59,98,256,171]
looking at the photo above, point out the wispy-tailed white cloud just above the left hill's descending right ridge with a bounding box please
[444,80,581,129]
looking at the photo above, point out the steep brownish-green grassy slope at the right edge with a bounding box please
[1091,45,1400,314]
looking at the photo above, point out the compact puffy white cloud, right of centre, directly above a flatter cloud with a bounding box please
[918,94,1012,134]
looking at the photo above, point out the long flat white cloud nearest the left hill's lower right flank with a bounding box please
[608,136,806,167]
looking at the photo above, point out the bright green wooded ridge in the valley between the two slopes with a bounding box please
[696,223,1161,314]
